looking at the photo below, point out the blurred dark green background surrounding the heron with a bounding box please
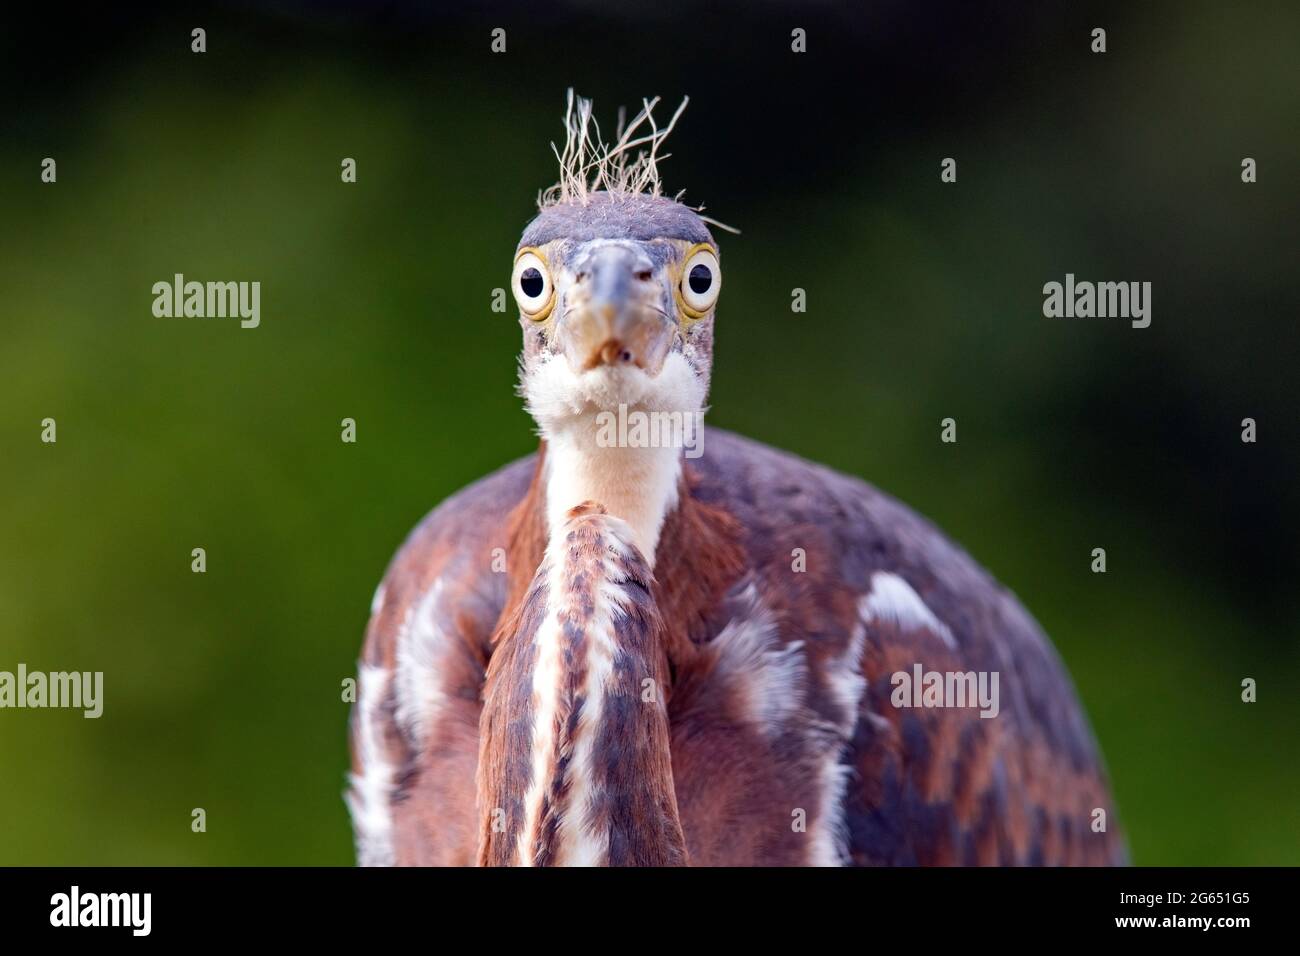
[0,1,1300,864]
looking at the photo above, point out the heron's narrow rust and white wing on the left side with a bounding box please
[347,457,533,865]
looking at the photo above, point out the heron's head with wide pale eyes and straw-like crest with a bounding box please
[511,99,722,433]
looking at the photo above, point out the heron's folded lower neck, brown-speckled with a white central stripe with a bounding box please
[478,503,686,866]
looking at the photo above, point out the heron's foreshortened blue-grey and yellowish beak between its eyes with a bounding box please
[559,246,673,376]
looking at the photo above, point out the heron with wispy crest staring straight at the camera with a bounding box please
[347,91,1126,866]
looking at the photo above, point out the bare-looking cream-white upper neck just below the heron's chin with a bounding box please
[545,415,683,568]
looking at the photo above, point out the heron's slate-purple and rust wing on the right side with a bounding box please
[697,429,1125,865]
